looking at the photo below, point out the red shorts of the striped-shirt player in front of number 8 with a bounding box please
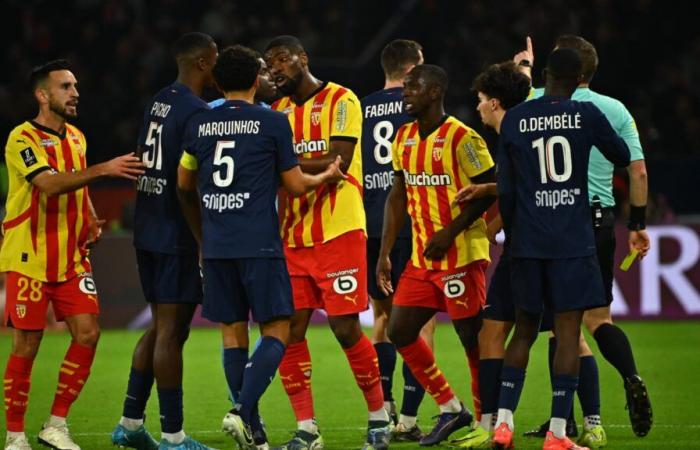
[393,259,488,320]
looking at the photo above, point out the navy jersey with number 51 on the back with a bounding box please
[134,83,208,254]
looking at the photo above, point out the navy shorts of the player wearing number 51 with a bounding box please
[136,249,202,304]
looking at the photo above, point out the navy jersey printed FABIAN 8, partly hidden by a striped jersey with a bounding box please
[361,87,412,238]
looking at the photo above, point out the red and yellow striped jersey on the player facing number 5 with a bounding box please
[272,82,365,247]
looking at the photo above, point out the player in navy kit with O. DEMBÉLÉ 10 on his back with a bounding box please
[493,49,630,450]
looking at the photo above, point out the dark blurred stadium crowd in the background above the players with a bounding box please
[0,0,700,162]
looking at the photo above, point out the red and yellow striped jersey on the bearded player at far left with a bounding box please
[0,122,91,282]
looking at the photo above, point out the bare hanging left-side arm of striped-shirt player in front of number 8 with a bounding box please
[376,171,408,295]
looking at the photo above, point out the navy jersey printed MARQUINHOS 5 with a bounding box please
[183,100,299,259]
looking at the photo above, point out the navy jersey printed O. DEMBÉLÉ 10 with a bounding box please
[497,96,630,259]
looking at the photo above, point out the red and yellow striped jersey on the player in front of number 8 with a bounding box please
[392,116,494,270]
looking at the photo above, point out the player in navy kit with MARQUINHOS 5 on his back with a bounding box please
[178,46,344,449]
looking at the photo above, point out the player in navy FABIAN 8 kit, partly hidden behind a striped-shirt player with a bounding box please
[361,39,435,441]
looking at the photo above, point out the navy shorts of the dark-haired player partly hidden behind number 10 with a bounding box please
[484,248,554,331]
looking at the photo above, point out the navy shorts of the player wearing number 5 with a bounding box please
[202,258,294,324]
